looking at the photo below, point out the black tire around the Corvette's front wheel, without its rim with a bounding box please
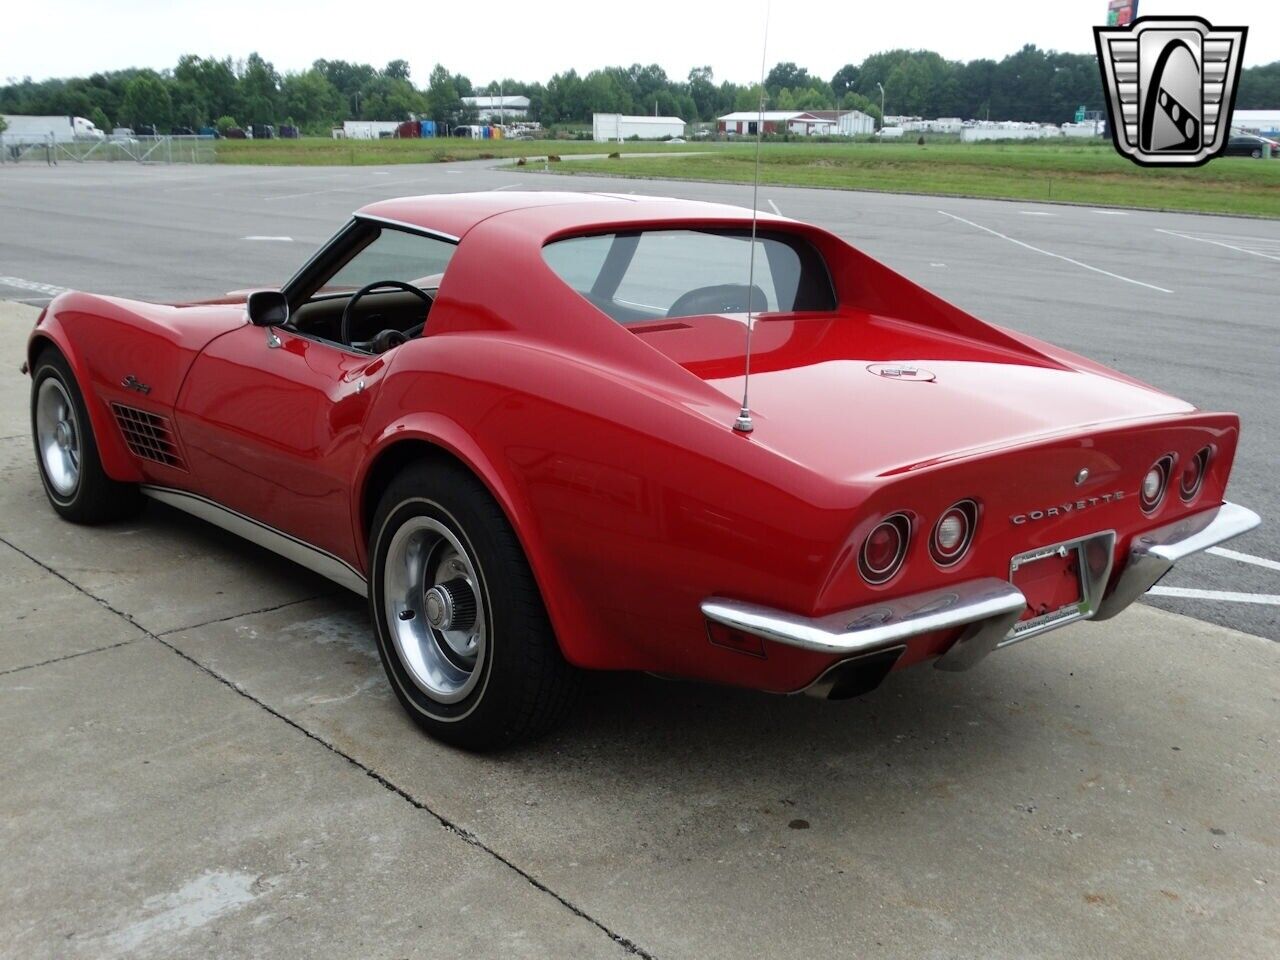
[31,347,143,524]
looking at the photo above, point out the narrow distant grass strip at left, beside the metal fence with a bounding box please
[218,137,705,166]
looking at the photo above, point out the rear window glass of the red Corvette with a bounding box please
[543,230,836,324]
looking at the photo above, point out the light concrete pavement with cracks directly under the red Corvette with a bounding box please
[0,305,1280,960]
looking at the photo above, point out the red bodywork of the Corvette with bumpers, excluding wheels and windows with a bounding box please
[31,192,1257,692]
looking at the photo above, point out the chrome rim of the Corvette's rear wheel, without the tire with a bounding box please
[383,516,488,703]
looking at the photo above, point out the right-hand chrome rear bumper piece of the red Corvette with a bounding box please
[1093,503,1262,620]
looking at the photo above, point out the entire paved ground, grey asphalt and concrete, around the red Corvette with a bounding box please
[0,165,1280,960]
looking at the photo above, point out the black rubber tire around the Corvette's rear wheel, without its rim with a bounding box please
[369,462,579,751]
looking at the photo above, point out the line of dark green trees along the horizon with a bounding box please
[0,45,1280,133]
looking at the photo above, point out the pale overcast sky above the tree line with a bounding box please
[10,0,1280,84]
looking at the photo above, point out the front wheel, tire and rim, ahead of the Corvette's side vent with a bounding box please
[31,348,142,524]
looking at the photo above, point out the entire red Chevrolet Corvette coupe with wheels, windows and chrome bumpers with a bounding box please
[27,193,1258,749]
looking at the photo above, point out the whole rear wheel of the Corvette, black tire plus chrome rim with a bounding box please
[369,463,577,750]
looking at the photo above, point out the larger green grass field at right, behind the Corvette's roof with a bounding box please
[519,142,1280,218]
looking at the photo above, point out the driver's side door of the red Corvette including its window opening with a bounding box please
[177,216,457,564]
